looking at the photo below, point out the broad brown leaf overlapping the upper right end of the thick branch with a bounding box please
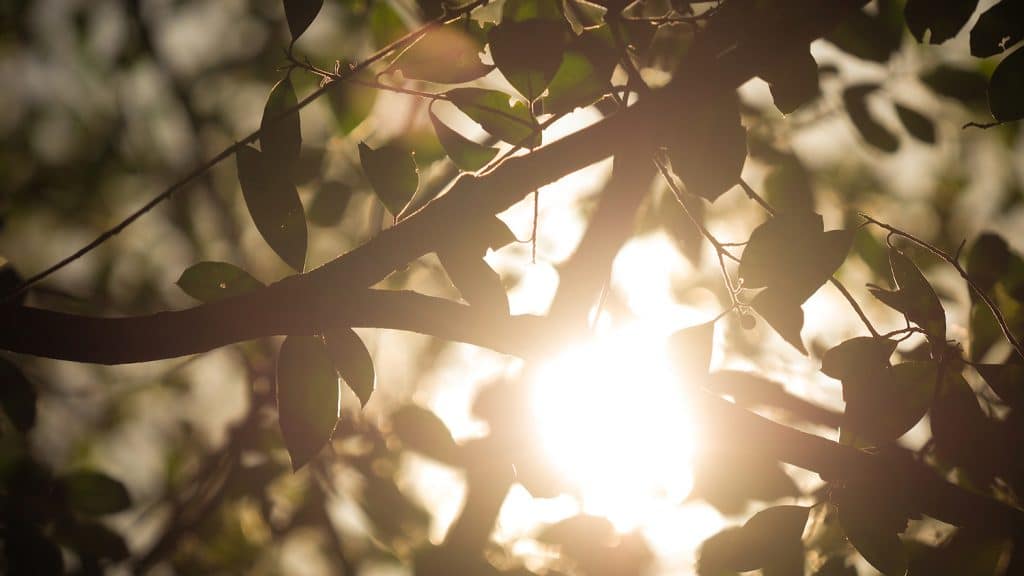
[669,96,746,201]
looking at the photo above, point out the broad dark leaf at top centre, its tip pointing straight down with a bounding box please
[487,18,568,101]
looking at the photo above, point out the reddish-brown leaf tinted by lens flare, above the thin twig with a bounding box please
[391,20,493,84]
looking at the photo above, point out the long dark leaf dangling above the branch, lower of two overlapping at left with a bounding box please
[237,146,306,272]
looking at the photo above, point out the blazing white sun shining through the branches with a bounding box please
[530,325,695,531]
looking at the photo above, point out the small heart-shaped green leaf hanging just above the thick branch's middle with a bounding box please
[359,142,420,217]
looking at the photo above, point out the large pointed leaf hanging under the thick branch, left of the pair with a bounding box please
[278,335,340,470]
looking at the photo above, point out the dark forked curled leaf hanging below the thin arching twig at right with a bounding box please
[869,248,946,349]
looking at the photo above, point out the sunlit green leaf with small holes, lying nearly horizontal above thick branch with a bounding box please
[445,88,541,149]
